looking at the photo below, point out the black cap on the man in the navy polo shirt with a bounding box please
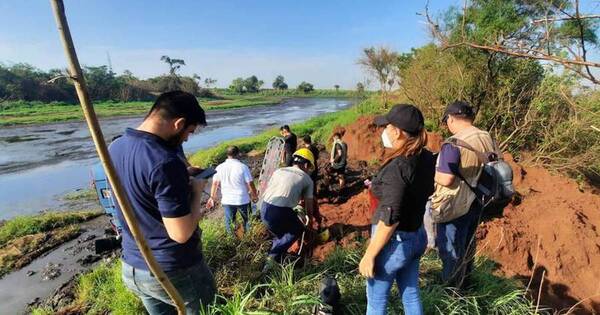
[146,91,206,126]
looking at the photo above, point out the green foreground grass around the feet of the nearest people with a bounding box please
[34,219,535,314]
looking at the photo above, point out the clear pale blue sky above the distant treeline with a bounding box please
[0,0,593,88]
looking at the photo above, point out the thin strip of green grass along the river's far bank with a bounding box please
[0,90,360,126]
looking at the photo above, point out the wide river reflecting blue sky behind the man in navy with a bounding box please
[0,98,352,219]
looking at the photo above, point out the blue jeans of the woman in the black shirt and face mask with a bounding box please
[367,225,427,315]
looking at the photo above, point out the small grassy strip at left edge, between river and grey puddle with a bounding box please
[0,211,100,247]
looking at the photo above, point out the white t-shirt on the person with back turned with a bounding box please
[213,159,252,206]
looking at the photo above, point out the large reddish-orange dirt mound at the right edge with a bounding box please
[478,156,600,312]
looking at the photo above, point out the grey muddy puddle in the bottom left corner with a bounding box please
[0,216,108,314]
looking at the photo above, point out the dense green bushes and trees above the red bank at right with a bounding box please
[359,0,600,184]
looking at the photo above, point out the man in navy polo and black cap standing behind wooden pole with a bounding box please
[109,91,216,314]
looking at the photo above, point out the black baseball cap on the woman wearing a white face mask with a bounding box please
[375,104,425,135]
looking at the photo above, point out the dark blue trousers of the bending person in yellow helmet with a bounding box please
[260,202,304,261]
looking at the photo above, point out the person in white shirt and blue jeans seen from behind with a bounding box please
[206,146,258,234]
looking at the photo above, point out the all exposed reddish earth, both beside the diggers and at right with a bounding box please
[304,116,600,314]
